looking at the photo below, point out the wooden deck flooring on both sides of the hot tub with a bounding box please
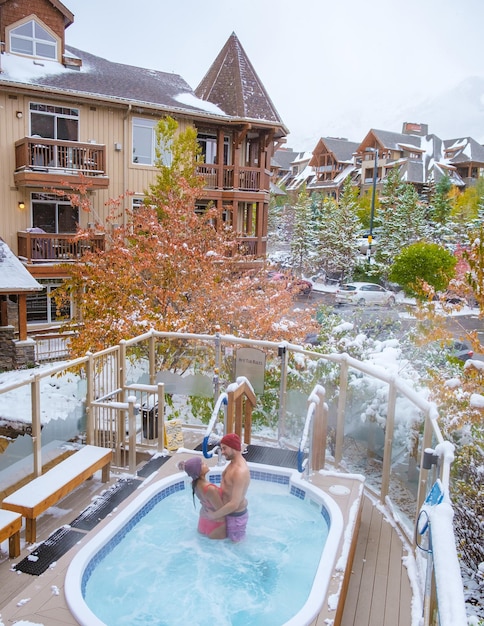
[0,450,412,626]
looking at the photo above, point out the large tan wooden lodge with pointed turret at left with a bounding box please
[0,0,288,346]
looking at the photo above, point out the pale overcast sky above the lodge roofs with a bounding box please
[64,0,484,150]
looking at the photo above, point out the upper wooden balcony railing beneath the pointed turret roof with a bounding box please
[197,163,269,191]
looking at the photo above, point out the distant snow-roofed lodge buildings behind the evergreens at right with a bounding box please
[284,122,484,199]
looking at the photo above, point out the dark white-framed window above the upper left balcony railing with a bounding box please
[30,102,79,141]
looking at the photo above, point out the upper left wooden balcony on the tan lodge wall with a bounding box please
[14,137,109,189]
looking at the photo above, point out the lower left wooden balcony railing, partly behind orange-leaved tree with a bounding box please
[17,231,104,263]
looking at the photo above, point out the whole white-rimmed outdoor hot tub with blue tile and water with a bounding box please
[65,464,343,626]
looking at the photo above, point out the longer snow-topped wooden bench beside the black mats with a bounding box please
[1,446,112,543]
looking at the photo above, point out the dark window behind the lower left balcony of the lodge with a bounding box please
[32,193,79,233]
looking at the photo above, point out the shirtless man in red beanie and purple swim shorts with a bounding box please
[208,433,250,541]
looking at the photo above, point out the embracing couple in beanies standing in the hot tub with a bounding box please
[180,433,250,541]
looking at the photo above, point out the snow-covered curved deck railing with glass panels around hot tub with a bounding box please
[0,330,468,626]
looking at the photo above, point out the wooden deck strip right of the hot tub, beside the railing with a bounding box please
[341,496,412,626]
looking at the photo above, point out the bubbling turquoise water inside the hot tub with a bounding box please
[85,480,328,626]
